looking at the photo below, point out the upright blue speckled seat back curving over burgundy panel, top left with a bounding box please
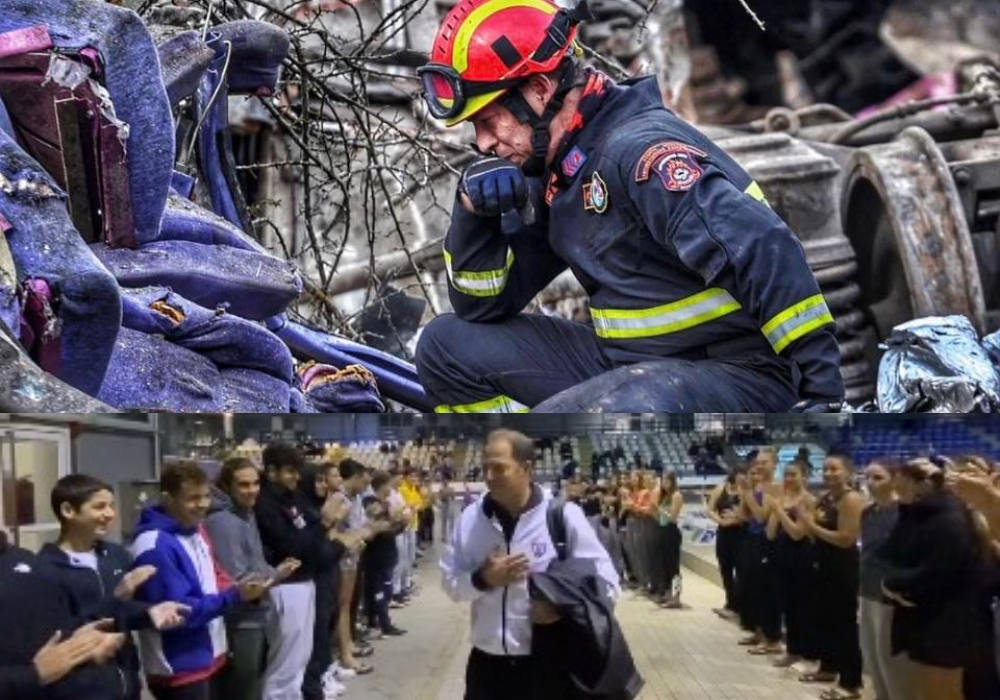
[0,0,175,243]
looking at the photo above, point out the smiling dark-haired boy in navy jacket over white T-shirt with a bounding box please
[39,474,184,700]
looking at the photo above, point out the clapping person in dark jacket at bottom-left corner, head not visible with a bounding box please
[0,530,125,700]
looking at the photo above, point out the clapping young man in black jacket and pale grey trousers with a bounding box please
[254,443,354,700]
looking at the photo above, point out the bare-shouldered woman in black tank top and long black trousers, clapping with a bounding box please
[799,452,865,700]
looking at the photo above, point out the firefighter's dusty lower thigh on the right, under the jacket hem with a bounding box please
[534,356,798,413]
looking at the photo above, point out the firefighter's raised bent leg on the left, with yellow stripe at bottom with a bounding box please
[416,314,611,413]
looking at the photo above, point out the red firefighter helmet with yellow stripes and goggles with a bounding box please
[417,0,576,126]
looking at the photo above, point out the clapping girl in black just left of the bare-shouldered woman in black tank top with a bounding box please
[767,462,817,668]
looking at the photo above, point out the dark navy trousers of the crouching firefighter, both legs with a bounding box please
[416,314,798,413]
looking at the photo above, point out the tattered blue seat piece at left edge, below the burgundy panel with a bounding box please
[0,132,122,396]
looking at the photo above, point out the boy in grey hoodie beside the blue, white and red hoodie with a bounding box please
[205,457,299,700]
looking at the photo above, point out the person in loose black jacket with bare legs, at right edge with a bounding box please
[879,460,998,700]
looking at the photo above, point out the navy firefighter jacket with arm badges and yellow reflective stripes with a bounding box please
[445,77,844,401]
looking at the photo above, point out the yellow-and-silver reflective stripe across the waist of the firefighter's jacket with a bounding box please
[590,288,742,338]
